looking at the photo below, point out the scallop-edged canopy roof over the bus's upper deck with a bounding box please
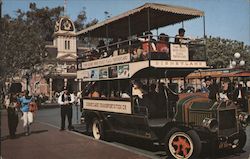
[77,3,204,38]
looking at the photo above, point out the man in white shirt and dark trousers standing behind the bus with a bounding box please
[58,88,75,131]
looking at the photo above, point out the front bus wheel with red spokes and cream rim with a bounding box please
[165,128,201,159]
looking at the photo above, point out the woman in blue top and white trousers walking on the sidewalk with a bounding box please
[18,91,33,135]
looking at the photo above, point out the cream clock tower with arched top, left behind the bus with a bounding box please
[46,16,79,94]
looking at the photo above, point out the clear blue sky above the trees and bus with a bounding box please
[2,0,250,45]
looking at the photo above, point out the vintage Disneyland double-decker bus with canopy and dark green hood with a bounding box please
[77,3,246,159]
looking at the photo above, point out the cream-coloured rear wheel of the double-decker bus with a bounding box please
[92,118,104,140]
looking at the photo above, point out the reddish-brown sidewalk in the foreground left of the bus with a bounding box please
[0,110,148,159]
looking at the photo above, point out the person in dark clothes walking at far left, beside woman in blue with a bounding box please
[5,93,18,138]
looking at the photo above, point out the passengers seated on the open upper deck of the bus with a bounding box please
[86,28,190,61]
